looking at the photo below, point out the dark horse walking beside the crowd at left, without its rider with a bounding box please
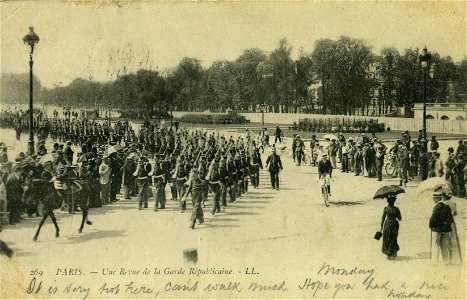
[33,179,92,241]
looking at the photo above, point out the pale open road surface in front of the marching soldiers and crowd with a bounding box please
[0,144,466,298]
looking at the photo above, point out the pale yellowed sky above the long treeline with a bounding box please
[0,1,466,87]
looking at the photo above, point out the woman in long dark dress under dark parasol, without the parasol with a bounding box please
[381,195,402,259]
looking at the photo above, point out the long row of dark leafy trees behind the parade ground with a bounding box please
[9,36,467,115]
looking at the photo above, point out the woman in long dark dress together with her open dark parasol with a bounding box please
[373,185,405,260]
